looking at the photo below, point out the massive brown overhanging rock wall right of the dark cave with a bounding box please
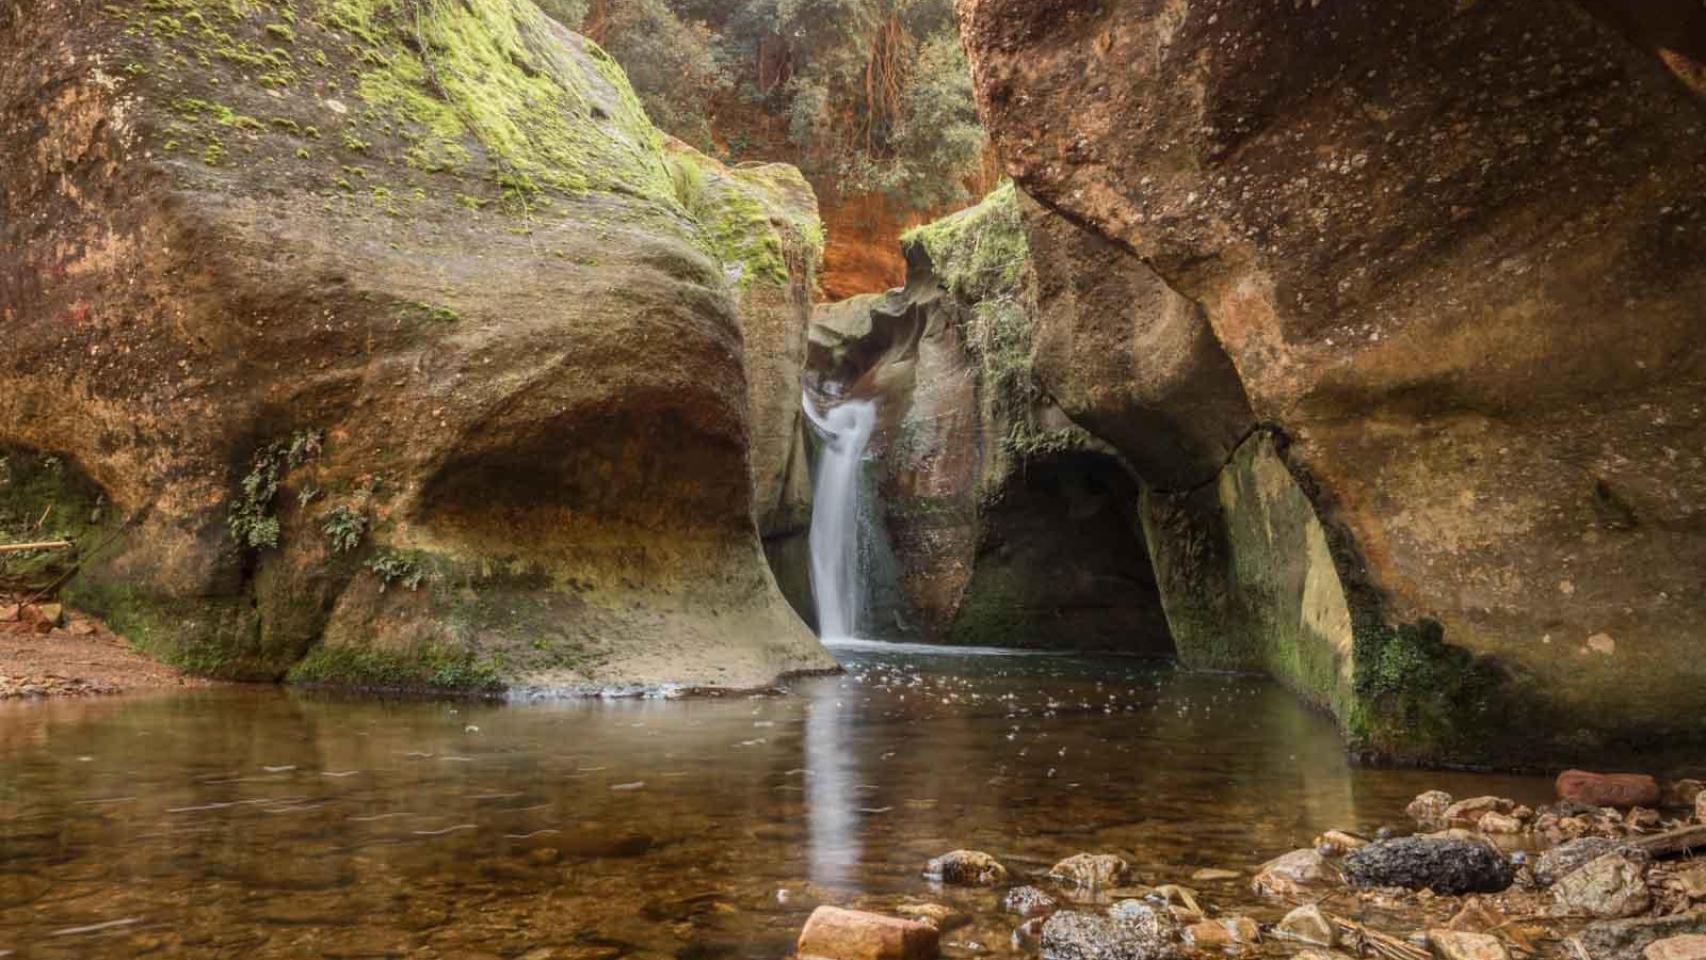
[957,0,1706,760]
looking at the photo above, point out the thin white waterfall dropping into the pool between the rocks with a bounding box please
[805,397,877,639]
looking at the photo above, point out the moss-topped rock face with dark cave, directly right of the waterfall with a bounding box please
[809,188,1172,655]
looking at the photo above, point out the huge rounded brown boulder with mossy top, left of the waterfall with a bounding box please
[0,0,831,689]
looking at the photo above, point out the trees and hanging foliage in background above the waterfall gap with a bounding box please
[543,0,993,215]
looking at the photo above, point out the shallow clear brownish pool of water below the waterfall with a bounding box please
[0,648,1547,960]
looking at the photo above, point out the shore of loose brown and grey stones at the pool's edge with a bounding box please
[797,771,1706,960]
